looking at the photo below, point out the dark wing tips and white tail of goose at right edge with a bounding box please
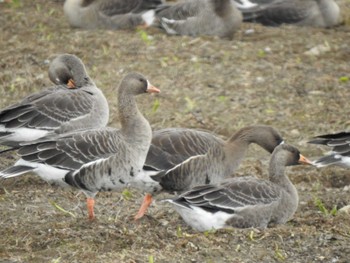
[309,132,350,168]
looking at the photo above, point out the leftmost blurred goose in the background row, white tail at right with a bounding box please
[63,0,162,30]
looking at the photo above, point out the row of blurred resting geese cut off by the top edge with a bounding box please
[64,0,342,39]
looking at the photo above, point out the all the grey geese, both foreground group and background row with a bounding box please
[0,0,350,231]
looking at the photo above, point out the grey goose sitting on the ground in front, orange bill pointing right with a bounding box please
[166,144,311,231]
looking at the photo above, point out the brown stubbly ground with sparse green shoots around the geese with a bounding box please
[0,0,350,262]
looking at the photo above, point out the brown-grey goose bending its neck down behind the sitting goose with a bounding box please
[135,125,283,219]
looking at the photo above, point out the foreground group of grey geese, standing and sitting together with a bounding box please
[0,54,350,231]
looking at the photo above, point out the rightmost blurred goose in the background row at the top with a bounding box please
[232,0,342,27]
